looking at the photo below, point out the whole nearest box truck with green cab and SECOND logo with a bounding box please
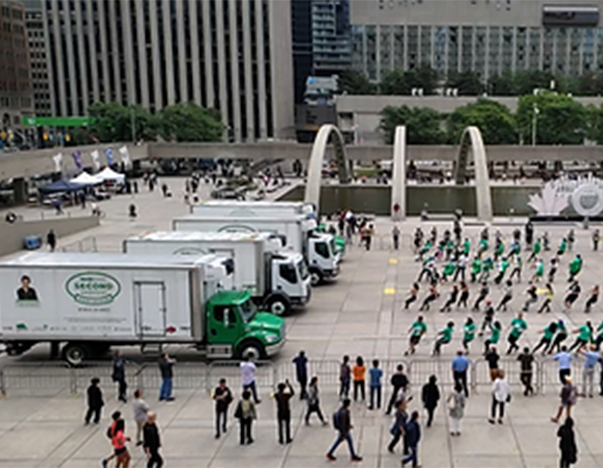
[0,253,285,365]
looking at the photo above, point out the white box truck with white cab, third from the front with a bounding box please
[172,214,341,286]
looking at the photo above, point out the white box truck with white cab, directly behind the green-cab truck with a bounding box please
[123,231,310,315]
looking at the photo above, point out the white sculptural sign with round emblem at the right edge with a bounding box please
[528,174,603,216]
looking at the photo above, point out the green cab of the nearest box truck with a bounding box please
[206,291,285,359]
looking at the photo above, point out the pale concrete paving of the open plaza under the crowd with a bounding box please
[0,179,603,468]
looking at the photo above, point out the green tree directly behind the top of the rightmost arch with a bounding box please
[446,99,517,145]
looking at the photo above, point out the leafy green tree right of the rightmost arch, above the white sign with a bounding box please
[516,91,588,145]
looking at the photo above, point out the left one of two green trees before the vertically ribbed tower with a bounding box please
[88,102,158,143]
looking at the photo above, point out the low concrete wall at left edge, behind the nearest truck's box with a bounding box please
[0,216,100,255]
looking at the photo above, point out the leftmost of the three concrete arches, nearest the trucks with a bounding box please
[304,124,351,211]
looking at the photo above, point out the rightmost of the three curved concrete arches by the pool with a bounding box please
[454,127,492,221]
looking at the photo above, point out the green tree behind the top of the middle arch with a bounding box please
[379,106,446,145]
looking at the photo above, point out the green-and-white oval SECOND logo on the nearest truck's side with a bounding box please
[65,271,121,306]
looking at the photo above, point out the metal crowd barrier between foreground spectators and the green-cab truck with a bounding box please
[0,357,584,397]
